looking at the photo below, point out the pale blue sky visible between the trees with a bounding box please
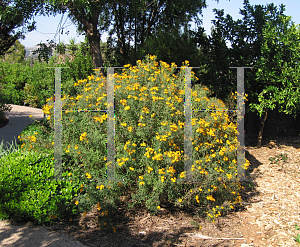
[20,0,300,47]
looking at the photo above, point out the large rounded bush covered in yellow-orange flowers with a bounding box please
[38,56,249,226]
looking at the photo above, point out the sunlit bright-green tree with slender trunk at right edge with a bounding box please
[250,16,300,147]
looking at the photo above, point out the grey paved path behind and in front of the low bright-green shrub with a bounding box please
[0,105,85,247]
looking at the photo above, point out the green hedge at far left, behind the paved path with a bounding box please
[0,37,93,108]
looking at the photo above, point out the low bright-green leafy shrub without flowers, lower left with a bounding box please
[0,147,79,224]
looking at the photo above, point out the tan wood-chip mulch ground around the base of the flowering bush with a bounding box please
[41,137,300,247]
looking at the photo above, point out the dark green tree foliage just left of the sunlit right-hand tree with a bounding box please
[204,0,285,111]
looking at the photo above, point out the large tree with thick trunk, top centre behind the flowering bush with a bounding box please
[38,0,225,68]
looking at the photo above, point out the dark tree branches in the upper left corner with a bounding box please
[0,0,43,56]
